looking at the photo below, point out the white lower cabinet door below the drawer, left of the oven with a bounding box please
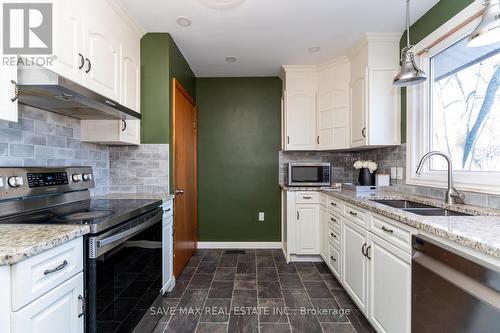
[11,273,84,333]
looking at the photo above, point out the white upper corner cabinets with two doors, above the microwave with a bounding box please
[283,58,350,150]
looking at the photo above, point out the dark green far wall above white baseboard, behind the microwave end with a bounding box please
[196,77,282,242]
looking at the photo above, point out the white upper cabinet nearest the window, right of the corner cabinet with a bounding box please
[350,33,401,147]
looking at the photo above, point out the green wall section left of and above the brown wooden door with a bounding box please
[141,33,196,143]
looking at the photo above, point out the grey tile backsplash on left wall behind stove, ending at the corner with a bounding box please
[0,105,110,194]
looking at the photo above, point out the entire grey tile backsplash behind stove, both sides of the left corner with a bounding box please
[0,105,169,195]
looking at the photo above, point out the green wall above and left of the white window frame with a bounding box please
[400,0,474,142]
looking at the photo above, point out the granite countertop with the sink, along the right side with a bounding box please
[281,186,500,258]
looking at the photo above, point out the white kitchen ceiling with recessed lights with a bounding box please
[118,0,439,77]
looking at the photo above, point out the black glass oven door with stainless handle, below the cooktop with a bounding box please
[86,208,162,333]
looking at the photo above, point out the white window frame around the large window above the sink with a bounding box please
[406,0,500,194]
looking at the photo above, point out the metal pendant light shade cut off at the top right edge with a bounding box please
[467,0,500,47]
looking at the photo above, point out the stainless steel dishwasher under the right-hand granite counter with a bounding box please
[412,236,500,333]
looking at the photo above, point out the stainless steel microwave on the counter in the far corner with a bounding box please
[285,163,331,186]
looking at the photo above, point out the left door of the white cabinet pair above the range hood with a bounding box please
[47,0,85,83]
